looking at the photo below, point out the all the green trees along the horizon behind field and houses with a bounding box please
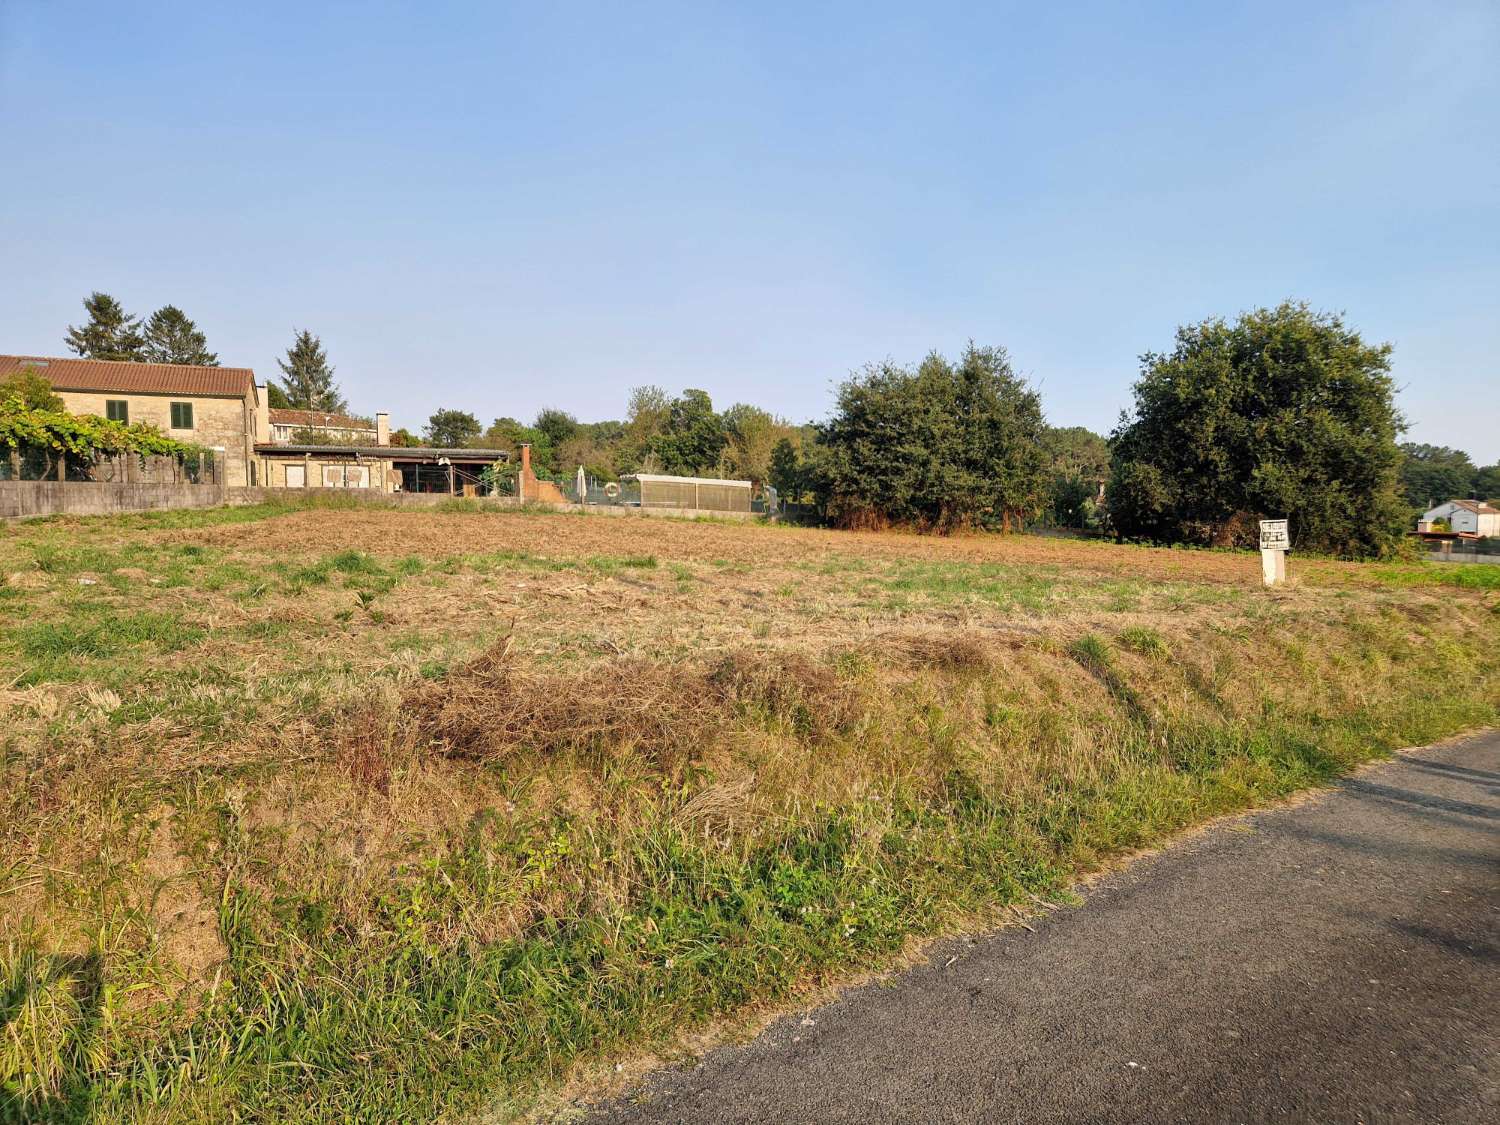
[58,293,1500,557]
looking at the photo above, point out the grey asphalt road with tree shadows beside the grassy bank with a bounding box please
[587,734,1500,1125]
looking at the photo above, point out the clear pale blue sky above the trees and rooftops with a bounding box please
[0,0,1500,464]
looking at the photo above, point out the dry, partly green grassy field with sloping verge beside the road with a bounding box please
[0,507,1500,1122]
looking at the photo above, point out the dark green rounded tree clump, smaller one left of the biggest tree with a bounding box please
[816,344,1047,531]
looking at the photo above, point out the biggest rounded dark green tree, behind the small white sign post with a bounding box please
[1109,302,1407,557]
